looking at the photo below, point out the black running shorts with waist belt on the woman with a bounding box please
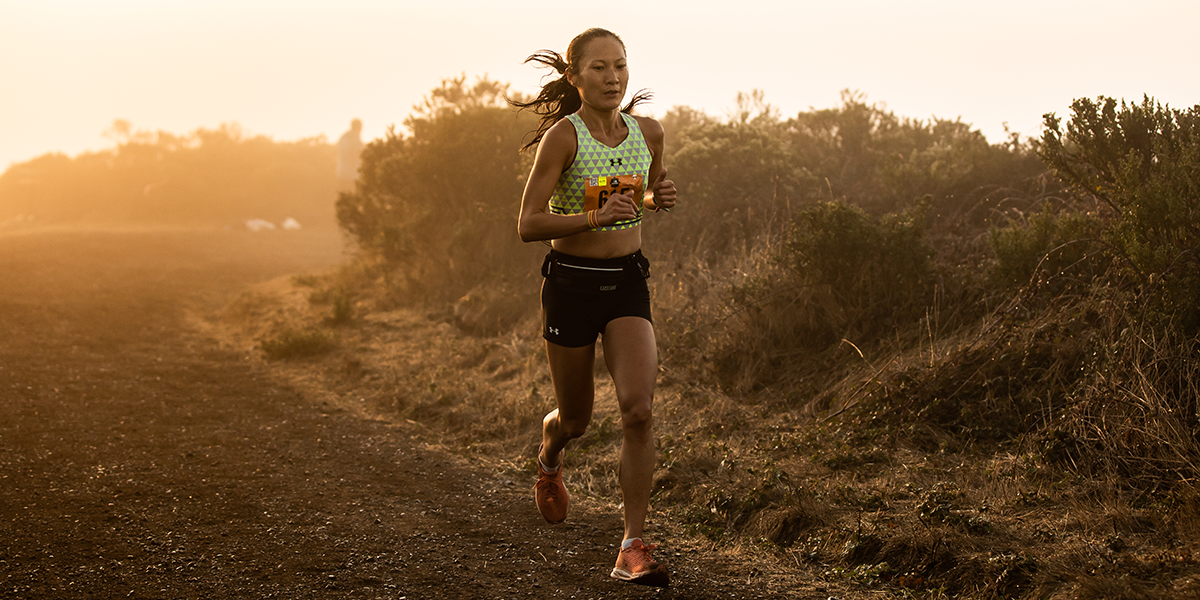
[541,250,653,348]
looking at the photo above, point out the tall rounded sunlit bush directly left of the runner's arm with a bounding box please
[337,77,540,302]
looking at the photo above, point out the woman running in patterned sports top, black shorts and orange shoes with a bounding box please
[514,29,676,587]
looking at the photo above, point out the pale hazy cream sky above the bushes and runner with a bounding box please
[0,0,1200,169]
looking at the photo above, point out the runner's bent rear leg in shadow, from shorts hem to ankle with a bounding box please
[538,342,596,469]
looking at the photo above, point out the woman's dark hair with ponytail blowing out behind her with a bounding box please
[509,28,652,150]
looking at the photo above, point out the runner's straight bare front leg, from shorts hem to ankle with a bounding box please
[604,317,659,540]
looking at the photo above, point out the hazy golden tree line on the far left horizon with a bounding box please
[0,120,336,227]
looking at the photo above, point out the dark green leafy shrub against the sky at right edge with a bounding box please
[1038,96,1200,335]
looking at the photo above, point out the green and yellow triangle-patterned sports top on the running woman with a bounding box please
[550,113,652,232]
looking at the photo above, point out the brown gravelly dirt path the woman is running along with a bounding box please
[0,230,848,599]
